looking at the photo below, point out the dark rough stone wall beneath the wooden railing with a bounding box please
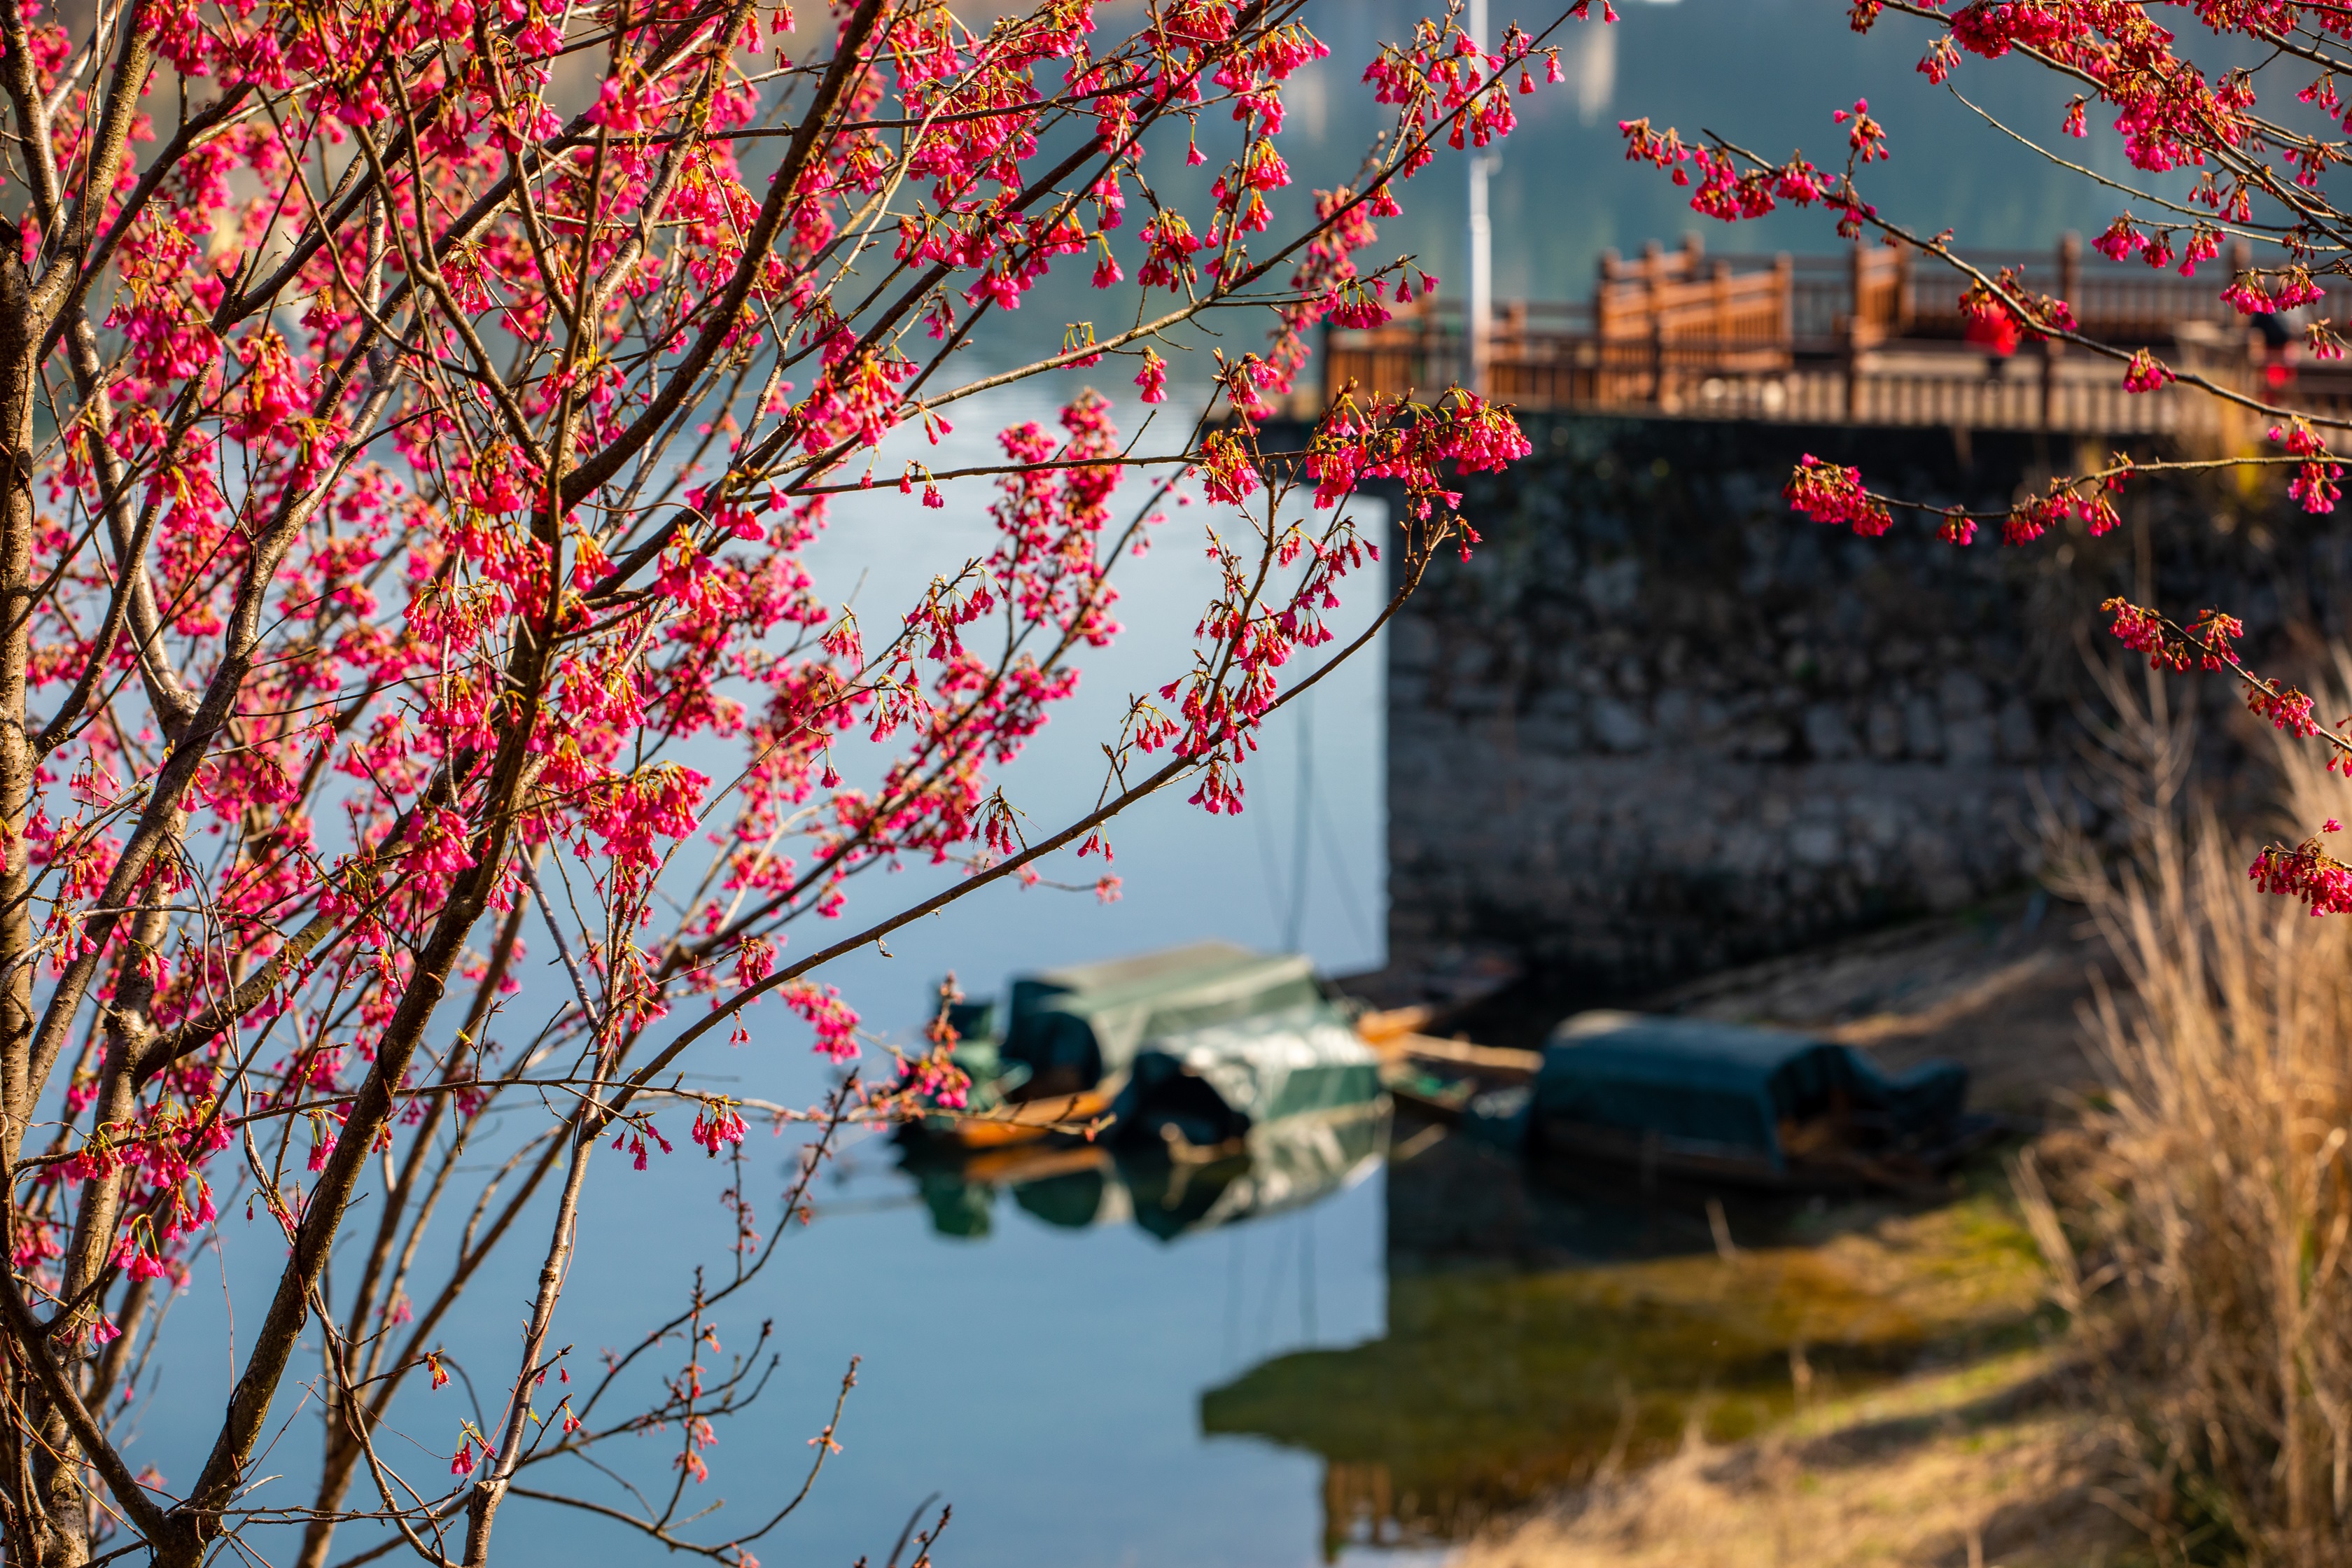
[1354,416,2352,995]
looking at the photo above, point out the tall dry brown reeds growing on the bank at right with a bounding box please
[2016,656,2352,1568]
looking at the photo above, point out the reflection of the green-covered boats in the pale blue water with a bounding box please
[899,1100,1387,1241]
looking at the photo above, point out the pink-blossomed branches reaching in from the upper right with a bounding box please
[1618,0,2352,914]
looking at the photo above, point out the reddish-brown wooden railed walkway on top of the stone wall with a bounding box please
[1320,235,2352,449]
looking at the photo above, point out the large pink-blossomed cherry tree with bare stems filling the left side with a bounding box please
[0,0,1560,1568]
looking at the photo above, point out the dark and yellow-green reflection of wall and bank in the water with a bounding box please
[1200,1135,2037,1561]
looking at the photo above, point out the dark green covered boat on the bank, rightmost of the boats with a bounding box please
[1529,1013,1968,1187]
